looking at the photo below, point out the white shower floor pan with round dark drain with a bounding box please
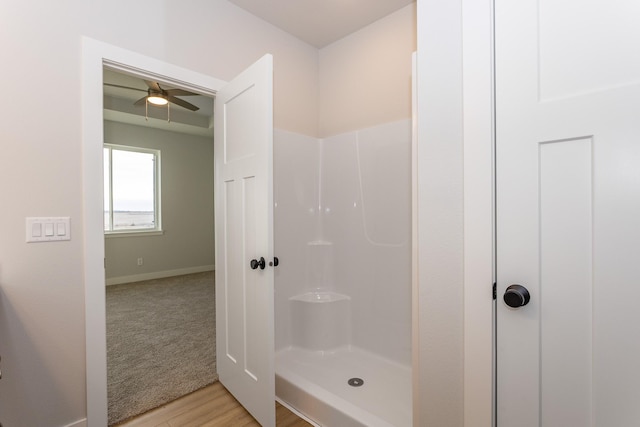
[276,346,412,427]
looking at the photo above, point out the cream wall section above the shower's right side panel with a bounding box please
[318,3,417,137]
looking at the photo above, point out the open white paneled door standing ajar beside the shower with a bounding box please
[214,55,275,427]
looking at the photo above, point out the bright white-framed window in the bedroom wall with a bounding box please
[104,144,161,233]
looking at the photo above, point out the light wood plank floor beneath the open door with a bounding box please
[117,382,311,427]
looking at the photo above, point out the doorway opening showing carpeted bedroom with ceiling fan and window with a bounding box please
[103,68,218,425]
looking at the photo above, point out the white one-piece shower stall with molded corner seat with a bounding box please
[274,119,412,427]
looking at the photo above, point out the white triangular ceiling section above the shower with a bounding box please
[229,0,415,48]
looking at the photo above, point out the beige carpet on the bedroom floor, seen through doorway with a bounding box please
[106,272,218,425]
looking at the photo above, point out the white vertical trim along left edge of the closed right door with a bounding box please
[458,0,497,426]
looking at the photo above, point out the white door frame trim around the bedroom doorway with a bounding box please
[81,37,226,426]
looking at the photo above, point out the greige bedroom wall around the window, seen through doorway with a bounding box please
[104,118,214,283]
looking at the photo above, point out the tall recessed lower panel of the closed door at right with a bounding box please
[539,138,593,426]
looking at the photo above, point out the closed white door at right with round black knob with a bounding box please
[495,0,640,427]
